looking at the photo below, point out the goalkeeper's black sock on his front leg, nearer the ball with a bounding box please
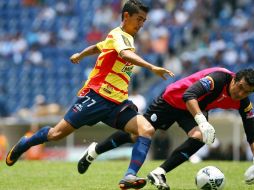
[160,138,204,172]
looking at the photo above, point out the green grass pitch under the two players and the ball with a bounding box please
[0,161,254,190]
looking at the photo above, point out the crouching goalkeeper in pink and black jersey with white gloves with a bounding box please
[78,67,254,190]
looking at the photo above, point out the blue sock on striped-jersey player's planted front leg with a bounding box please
[125,136,151,176]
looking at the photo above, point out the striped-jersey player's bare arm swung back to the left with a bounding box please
[70,45,101,64]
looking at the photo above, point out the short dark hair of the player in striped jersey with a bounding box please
[122,0,149,20]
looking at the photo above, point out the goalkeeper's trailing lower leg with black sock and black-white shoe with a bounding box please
[78,130,132,174]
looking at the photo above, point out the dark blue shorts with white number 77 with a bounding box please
[64,90,138,129]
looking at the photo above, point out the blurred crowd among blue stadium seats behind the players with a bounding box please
[0,0,254,116]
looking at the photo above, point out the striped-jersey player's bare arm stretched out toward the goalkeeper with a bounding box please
[119,49,174,80]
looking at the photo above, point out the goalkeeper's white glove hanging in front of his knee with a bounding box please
[198,122,215,145]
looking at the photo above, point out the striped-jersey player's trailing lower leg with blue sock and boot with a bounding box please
[6,119,75,166]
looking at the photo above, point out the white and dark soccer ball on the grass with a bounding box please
[195,166,225,190]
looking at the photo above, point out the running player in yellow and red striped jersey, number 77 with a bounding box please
[6,0,173,189]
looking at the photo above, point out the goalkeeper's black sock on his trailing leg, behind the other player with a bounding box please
[95,131,132,154]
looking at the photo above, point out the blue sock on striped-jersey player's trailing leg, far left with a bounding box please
[24,126,50,149]
